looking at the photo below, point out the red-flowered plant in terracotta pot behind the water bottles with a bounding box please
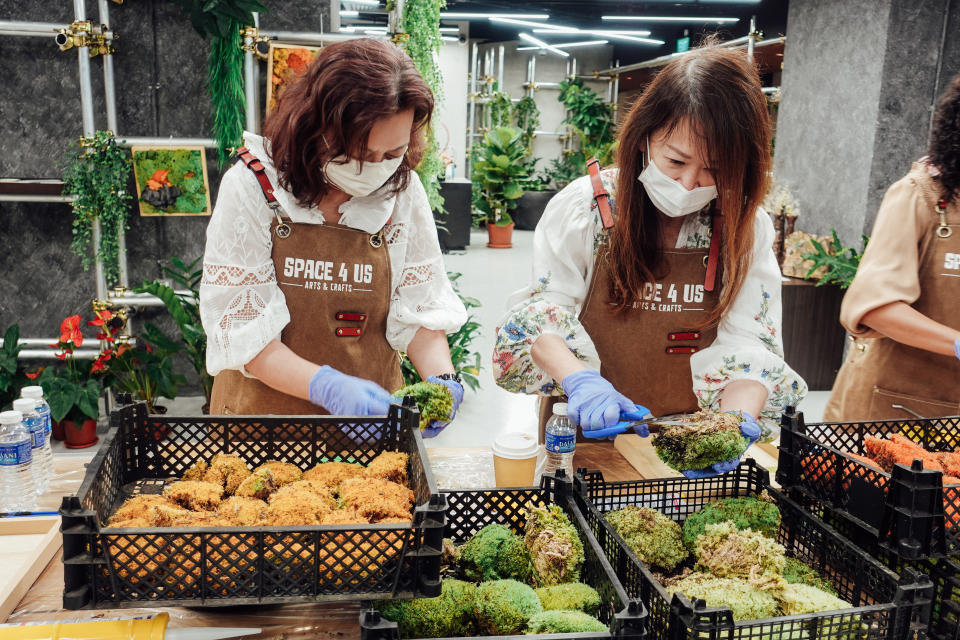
[37,315,104,449]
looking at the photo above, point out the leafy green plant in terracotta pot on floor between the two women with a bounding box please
[473,127,530,249]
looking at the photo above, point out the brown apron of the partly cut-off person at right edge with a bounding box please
[824,170,960,422]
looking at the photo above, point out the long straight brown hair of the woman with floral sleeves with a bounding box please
[609,45,770,326]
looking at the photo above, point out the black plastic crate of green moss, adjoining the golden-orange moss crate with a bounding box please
[360,478,647,640]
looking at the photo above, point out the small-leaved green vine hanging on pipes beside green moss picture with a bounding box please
[63,131,133,286]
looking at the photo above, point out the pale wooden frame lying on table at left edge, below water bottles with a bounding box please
[0,516,63,623]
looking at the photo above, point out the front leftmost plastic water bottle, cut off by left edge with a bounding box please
[0,411,37,513]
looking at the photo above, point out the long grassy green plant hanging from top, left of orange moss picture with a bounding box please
[173,0,267,168]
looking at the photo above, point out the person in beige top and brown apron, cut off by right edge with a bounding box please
[825,75,960,421]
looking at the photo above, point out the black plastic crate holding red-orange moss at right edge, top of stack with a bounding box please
[777,409,960,559]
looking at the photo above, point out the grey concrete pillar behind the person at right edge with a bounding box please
[774,0,960,241]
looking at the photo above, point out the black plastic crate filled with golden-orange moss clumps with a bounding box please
[60,403,446,609]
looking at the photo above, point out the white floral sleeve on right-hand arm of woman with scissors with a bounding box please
[690,209,807,440]
